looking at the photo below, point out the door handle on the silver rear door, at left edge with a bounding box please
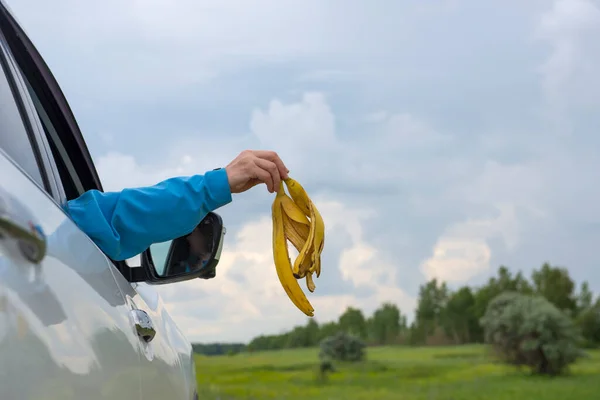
[0,191,47,264]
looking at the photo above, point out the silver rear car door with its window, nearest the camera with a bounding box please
[0,33,141,399]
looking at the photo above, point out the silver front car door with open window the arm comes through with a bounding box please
[0,0,196,400]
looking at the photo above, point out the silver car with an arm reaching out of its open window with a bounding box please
[0,0,225,400]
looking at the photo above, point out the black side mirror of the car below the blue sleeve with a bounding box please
[133,212,226,284]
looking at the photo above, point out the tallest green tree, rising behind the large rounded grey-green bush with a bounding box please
[531,263,577,315]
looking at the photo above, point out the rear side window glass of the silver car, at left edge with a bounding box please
[0,42,44,187]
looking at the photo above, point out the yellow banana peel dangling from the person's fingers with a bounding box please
[271,178,325,317]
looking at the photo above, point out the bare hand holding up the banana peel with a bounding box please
[225,150,289,193]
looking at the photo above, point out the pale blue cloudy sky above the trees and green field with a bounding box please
[7,0,600,342]
